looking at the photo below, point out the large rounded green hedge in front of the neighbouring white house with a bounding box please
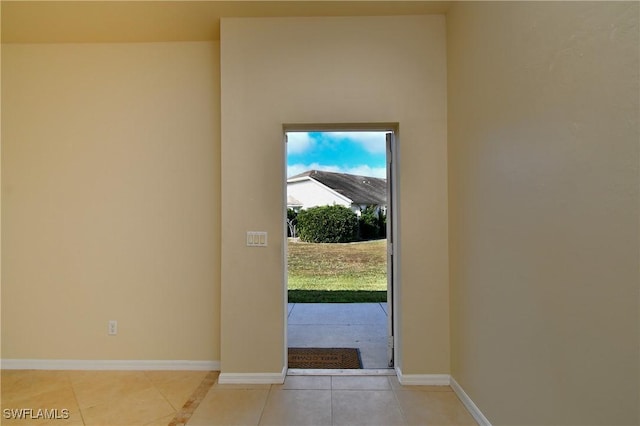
[297,206,358,243]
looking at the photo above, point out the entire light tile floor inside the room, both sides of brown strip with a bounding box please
[1,370,476,426]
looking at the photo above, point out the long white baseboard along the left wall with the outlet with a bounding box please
[0,359,220,371]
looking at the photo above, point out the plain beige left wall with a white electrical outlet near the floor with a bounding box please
[2,42,220,361]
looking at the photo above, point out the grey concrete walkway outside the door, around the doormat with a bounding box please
[287,303,388,369]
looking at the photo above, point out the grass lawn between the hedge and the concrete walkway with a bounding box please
[288,240,387,303]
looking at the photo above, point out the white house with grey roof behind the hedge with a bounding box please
[287,170,387,215]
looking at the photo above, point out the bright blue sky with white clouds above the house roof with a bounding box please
[287,132,387,178]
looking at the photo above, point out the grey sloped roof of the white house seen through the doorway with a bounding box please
[288,170,387,205]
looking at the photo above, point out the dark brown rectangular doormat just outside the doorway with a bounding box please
[289,348,362,369]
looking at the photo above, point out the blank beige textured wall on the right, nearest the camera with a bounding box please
[447,2,640,425]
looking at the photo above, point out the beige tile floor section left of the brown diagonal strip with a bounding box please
[0,370,209,426]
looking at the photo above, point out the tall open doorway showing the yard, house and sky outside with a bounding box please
[284,125,397,372]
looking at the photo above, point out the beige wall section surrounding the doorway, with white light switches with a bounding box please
[221,15,449,374]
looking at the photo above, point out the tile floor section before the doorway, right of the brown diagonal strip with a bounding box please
[188,376,476,426]
